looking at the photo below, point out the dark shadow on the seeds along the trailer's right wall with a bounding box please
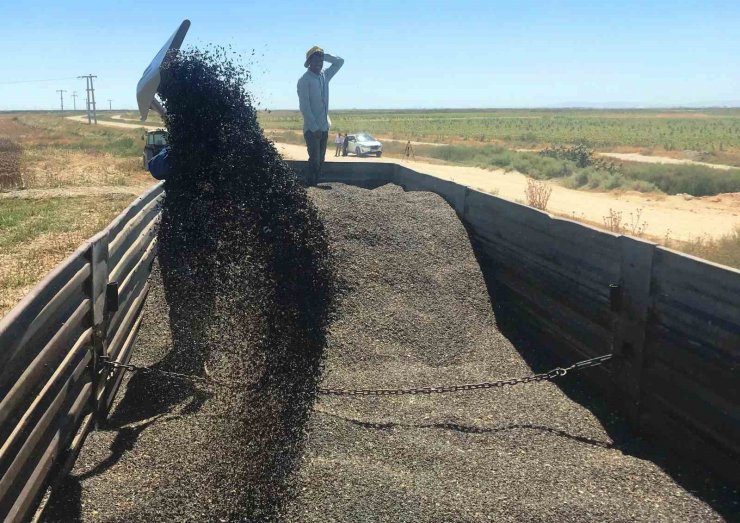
[466,231,739,521]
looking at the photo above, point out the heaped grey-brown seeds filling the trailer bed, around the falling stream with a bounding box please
[43,184,737,522]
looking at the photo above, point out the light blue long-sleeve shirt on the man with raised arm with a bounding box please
[298,54,344,132]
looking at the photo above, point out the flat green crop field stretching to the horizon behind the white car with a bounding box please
[260,109,740,153]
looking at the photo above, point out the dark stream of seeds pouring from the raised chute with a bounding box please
[159,50,335,520]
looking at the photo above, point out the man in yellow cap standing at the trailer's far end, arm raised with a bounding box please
[298,46,344,185]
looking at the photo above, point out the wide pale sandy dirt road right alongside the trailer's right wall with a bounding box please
[277,143,740,240]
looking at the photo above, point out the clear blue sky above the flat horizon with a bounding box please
[0,0,740,110]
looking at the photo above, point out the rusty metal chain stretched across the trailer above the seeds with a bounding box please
[103,354,612,396]
